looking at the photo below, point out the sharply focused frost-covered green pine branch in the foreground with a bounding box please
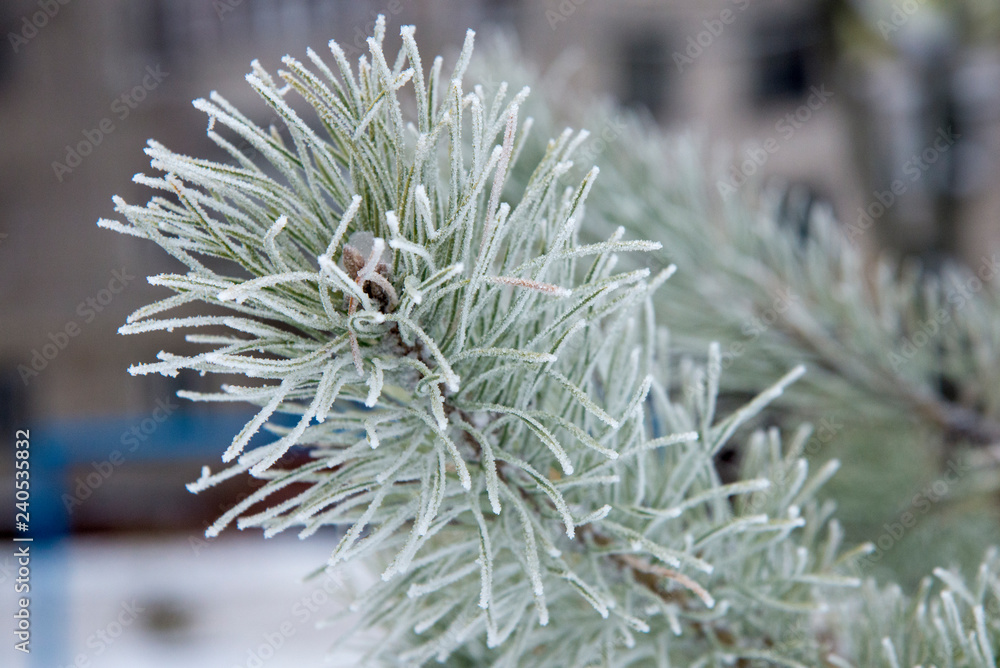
[100,19,1000,667]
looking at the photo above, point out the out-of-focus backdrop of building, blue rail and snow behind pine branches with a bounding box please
[0,0,1000,668]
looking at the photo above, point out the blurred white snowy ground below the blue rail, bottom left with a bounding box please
[0,532,378,668]
